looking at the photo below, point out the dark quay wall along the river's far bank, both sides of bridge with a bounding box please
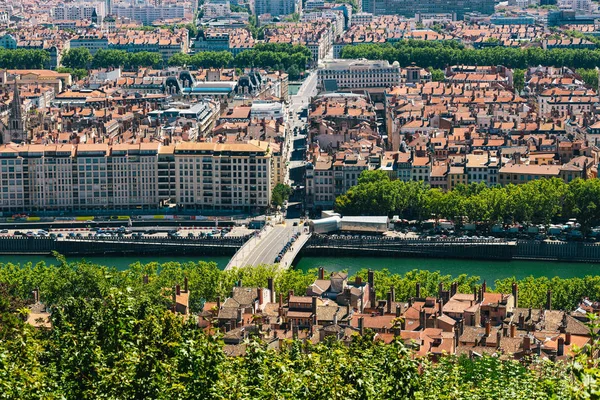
[0,234,600,263]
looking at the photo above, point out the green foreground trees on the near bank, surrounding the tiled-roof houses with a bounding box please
[0,257,600,400]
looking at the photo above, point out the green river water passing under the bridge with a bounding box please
[0,256,600,282]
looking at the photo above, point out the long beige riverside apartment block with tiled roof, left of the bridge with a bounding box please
[0,142,272,213]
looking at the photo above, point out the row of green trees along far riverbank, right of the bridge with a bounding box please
[335,171,600,231]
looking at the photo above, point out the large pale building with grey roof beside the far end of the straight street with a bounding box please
[317,59,401,90]
